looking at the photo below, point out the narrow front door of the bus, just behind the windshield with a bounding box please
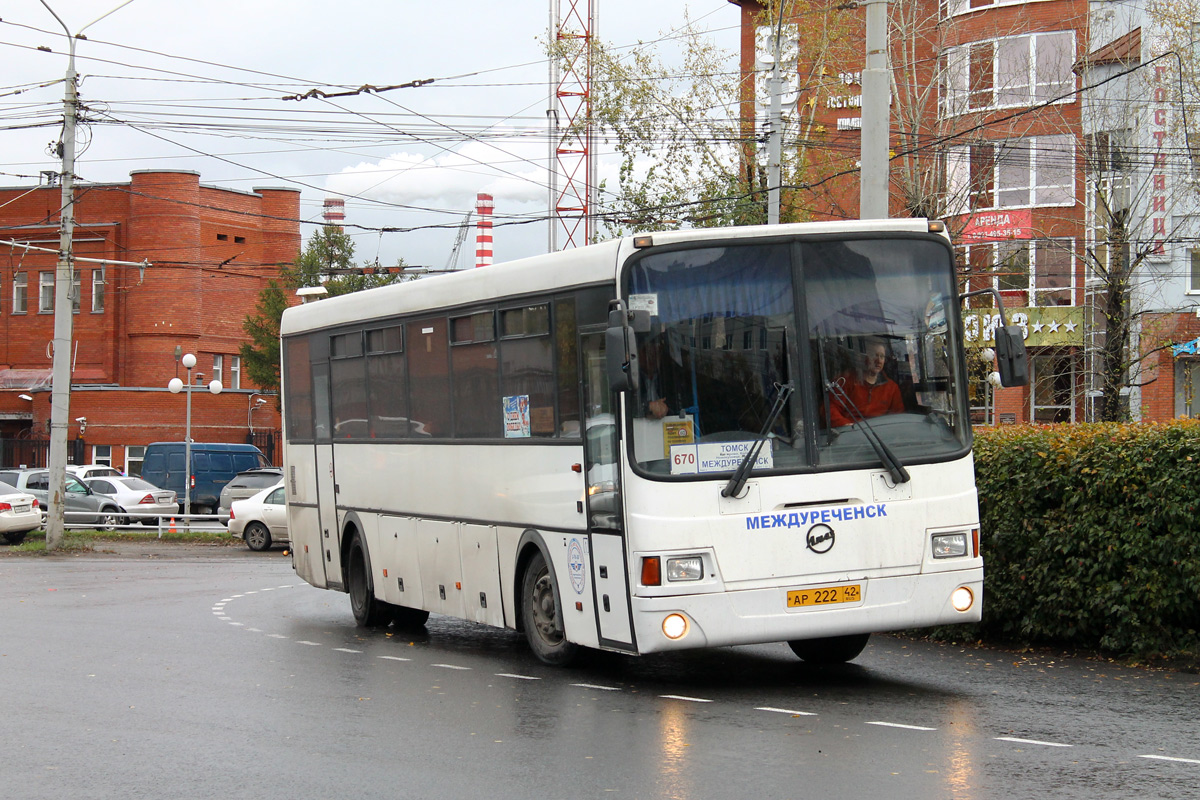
[580,329,637,652]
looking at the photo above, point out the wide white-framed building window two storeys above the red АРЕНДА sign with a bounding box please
[941,31,1075,116]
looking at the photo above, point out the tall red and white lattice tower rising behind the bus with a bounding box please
[547,0,598,251]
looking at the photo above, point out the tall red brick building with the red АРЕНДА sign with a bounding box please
[731,0,1104,423]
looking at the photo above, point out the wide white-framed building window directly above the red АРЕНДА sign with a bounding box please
[947,136,1075,213]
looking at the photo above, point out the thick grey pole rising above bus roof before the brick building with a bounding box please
[858,0,892,219]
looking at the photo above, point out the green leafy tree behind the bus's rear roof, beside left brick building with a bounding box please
[239,225,404,392]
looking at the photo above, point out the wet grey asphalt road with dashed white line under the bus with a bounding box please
[0,546,1200,800]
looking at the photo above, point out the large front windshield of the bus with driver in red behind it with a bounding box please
[625,236,970,476]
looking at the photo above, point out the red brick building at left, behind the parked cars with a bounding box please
[0,170,300,473]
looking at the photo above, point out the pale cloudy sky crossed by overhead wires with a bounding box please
[0,0,739,269]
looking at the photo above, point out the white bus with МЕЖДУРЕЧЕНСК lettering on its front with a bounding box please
[281,219,1024,664]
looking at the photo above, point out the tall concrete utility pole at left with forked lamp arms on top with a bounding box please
[42,0,133,551]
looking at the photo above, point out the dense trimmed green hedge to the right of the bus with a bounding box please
[976,420,1200,657]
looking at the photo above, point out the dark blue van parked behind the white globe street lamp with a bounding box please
[142,441,270,515]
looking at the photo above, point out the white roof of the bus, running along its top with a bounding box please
[280,219,929,336]
